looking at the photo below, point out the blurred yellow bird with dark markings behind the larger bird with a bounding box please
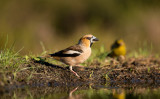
[107,39,126,58]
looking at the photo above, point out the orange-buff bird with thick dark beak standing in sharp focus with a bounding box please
[45,34,99,77]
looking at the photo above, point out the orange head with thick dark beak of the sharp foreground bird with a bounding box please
[78,34,99,47]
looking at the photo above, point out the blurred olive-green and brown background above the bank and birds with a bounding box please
[0,0,160,54]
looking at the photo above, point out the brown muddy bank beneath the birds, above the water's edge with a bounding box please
[0,57,160,89]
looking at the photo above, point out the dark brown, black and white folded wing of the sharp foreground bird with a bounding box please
[50,45,83,57]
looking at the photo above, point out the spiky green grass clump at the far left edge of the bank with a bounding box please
[0,36,27,85]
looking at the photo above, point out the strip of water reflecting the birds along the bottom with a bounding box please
[0,84,160,99]
